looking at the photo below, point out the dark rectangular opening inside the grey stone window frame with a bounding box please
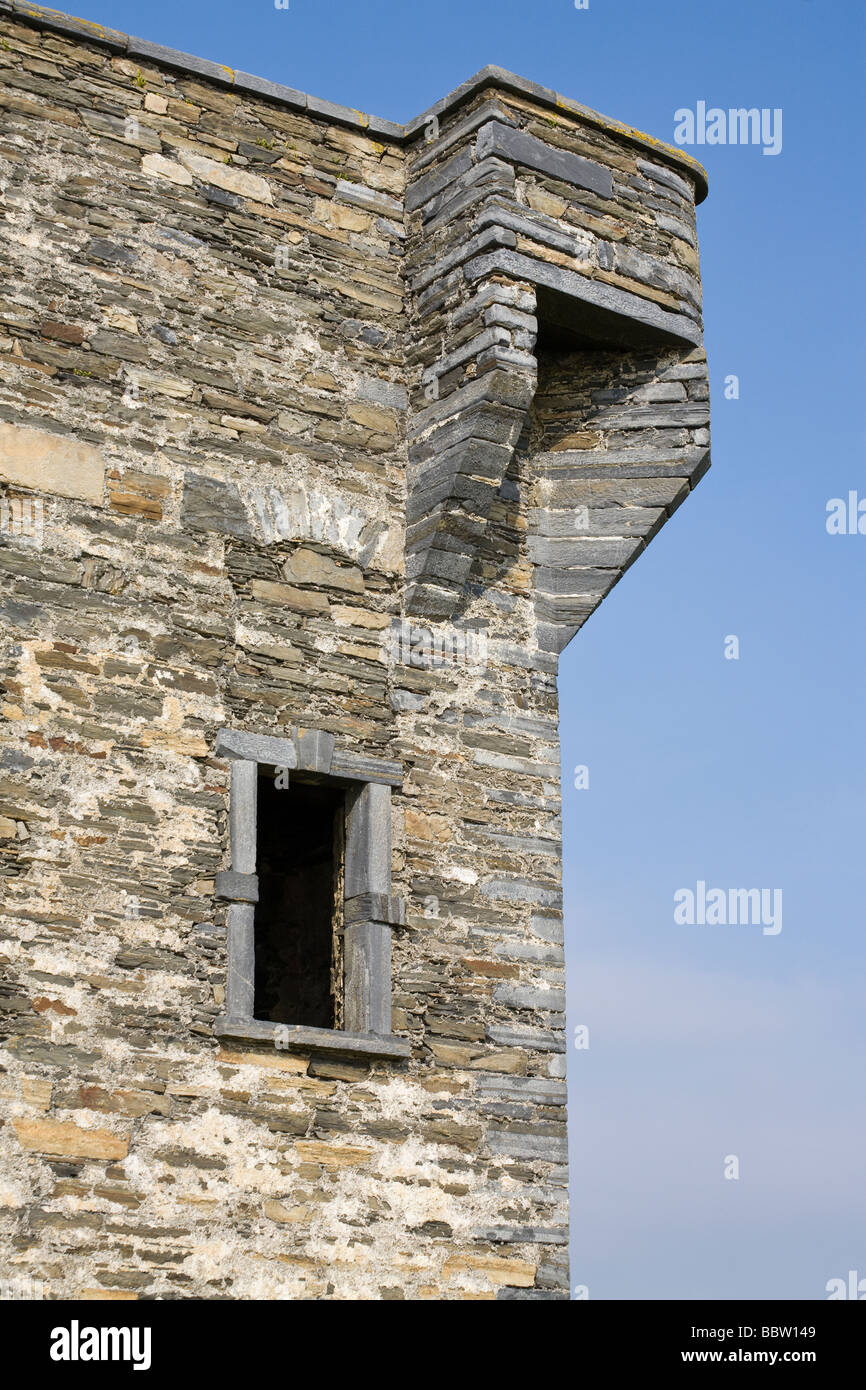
[254,769,343,1029]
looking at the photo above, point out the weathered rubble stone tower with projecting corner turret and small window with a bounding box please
[0,0,709,1300]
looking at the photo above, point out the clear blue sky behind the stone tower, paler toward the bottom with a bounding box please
[69,0,866,1298]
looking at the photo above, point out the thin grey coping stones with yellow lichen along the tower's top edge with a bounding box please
[8,0,708,203]
